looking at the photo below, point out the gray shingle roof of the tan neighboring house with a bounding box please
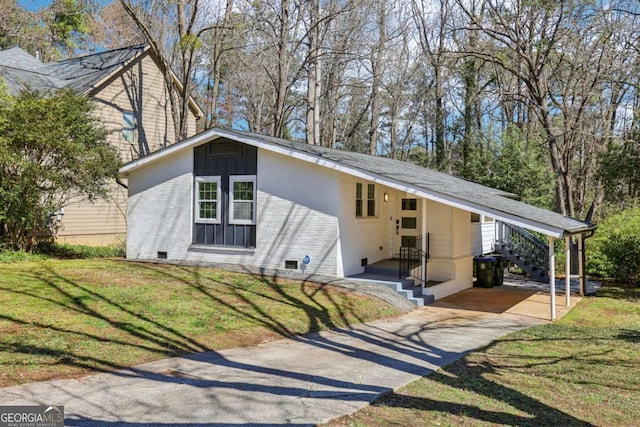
[0,46,145,94]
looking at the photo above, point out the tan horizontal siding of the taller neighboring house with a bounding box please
[56,52,196,245]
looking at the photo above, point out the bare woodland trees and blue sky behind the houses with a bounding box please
[0,0,640,224]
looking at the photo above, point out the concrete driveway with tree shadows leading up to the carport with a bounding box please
[0,306,546,426]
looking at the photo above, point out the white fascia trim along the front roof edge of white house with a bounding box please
[120,128,595,238]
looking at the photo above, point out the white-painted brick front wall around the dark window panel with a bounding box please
[127,145,338,277]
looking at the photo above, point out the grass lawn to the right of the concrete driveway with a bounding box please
[329,285,640,427]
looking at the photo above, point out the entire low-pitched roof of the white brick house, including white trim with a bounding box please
[120,128,595,238]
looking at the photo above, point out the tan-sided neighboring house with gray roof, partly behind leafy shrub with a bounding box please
[0,46,202,245]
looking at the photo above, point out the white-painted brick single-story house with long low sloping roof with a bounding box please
[120,129,594,318]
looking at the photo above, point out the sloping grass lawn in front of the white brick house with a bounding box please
[0,257,399,387]
